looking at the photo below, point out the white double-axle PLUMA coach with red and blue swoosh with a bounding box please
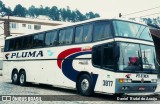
[3,18,158,96]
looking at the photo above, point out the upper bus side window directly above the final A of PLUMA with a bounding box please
[33,33,44,47]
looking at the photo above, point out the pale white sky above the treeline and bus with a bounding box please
[2,0,160,18]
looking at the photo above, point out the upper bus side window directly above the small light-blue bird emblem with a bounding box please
[45,31,57,46]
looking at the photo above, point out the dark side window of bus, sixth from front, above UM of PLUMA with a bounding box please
[23,36,32,48]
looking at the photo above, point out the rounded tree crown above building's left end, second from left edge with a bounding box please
[13,4,26,17]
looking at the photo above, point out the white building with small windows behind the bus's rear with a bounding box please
[0,16,68,69]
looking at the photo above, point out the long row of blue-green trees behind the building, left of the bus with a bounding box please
[0,0,100,22]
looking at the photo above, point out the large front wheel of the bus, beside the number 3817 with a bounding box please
[77,74,93,96]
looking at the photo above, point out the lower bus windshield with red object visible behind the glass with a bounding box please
[117,42,156,73]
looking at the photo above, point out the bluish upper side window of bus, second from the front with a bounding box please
[75,24,92,43]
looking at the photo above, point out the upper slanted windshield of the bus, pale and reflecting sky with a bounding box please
[113,20,153,41]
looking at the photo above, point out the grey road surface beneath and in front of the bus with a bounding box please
[0,76,160,104]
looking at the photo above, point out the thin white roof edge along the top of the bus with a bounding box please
[6,18,147,39]
